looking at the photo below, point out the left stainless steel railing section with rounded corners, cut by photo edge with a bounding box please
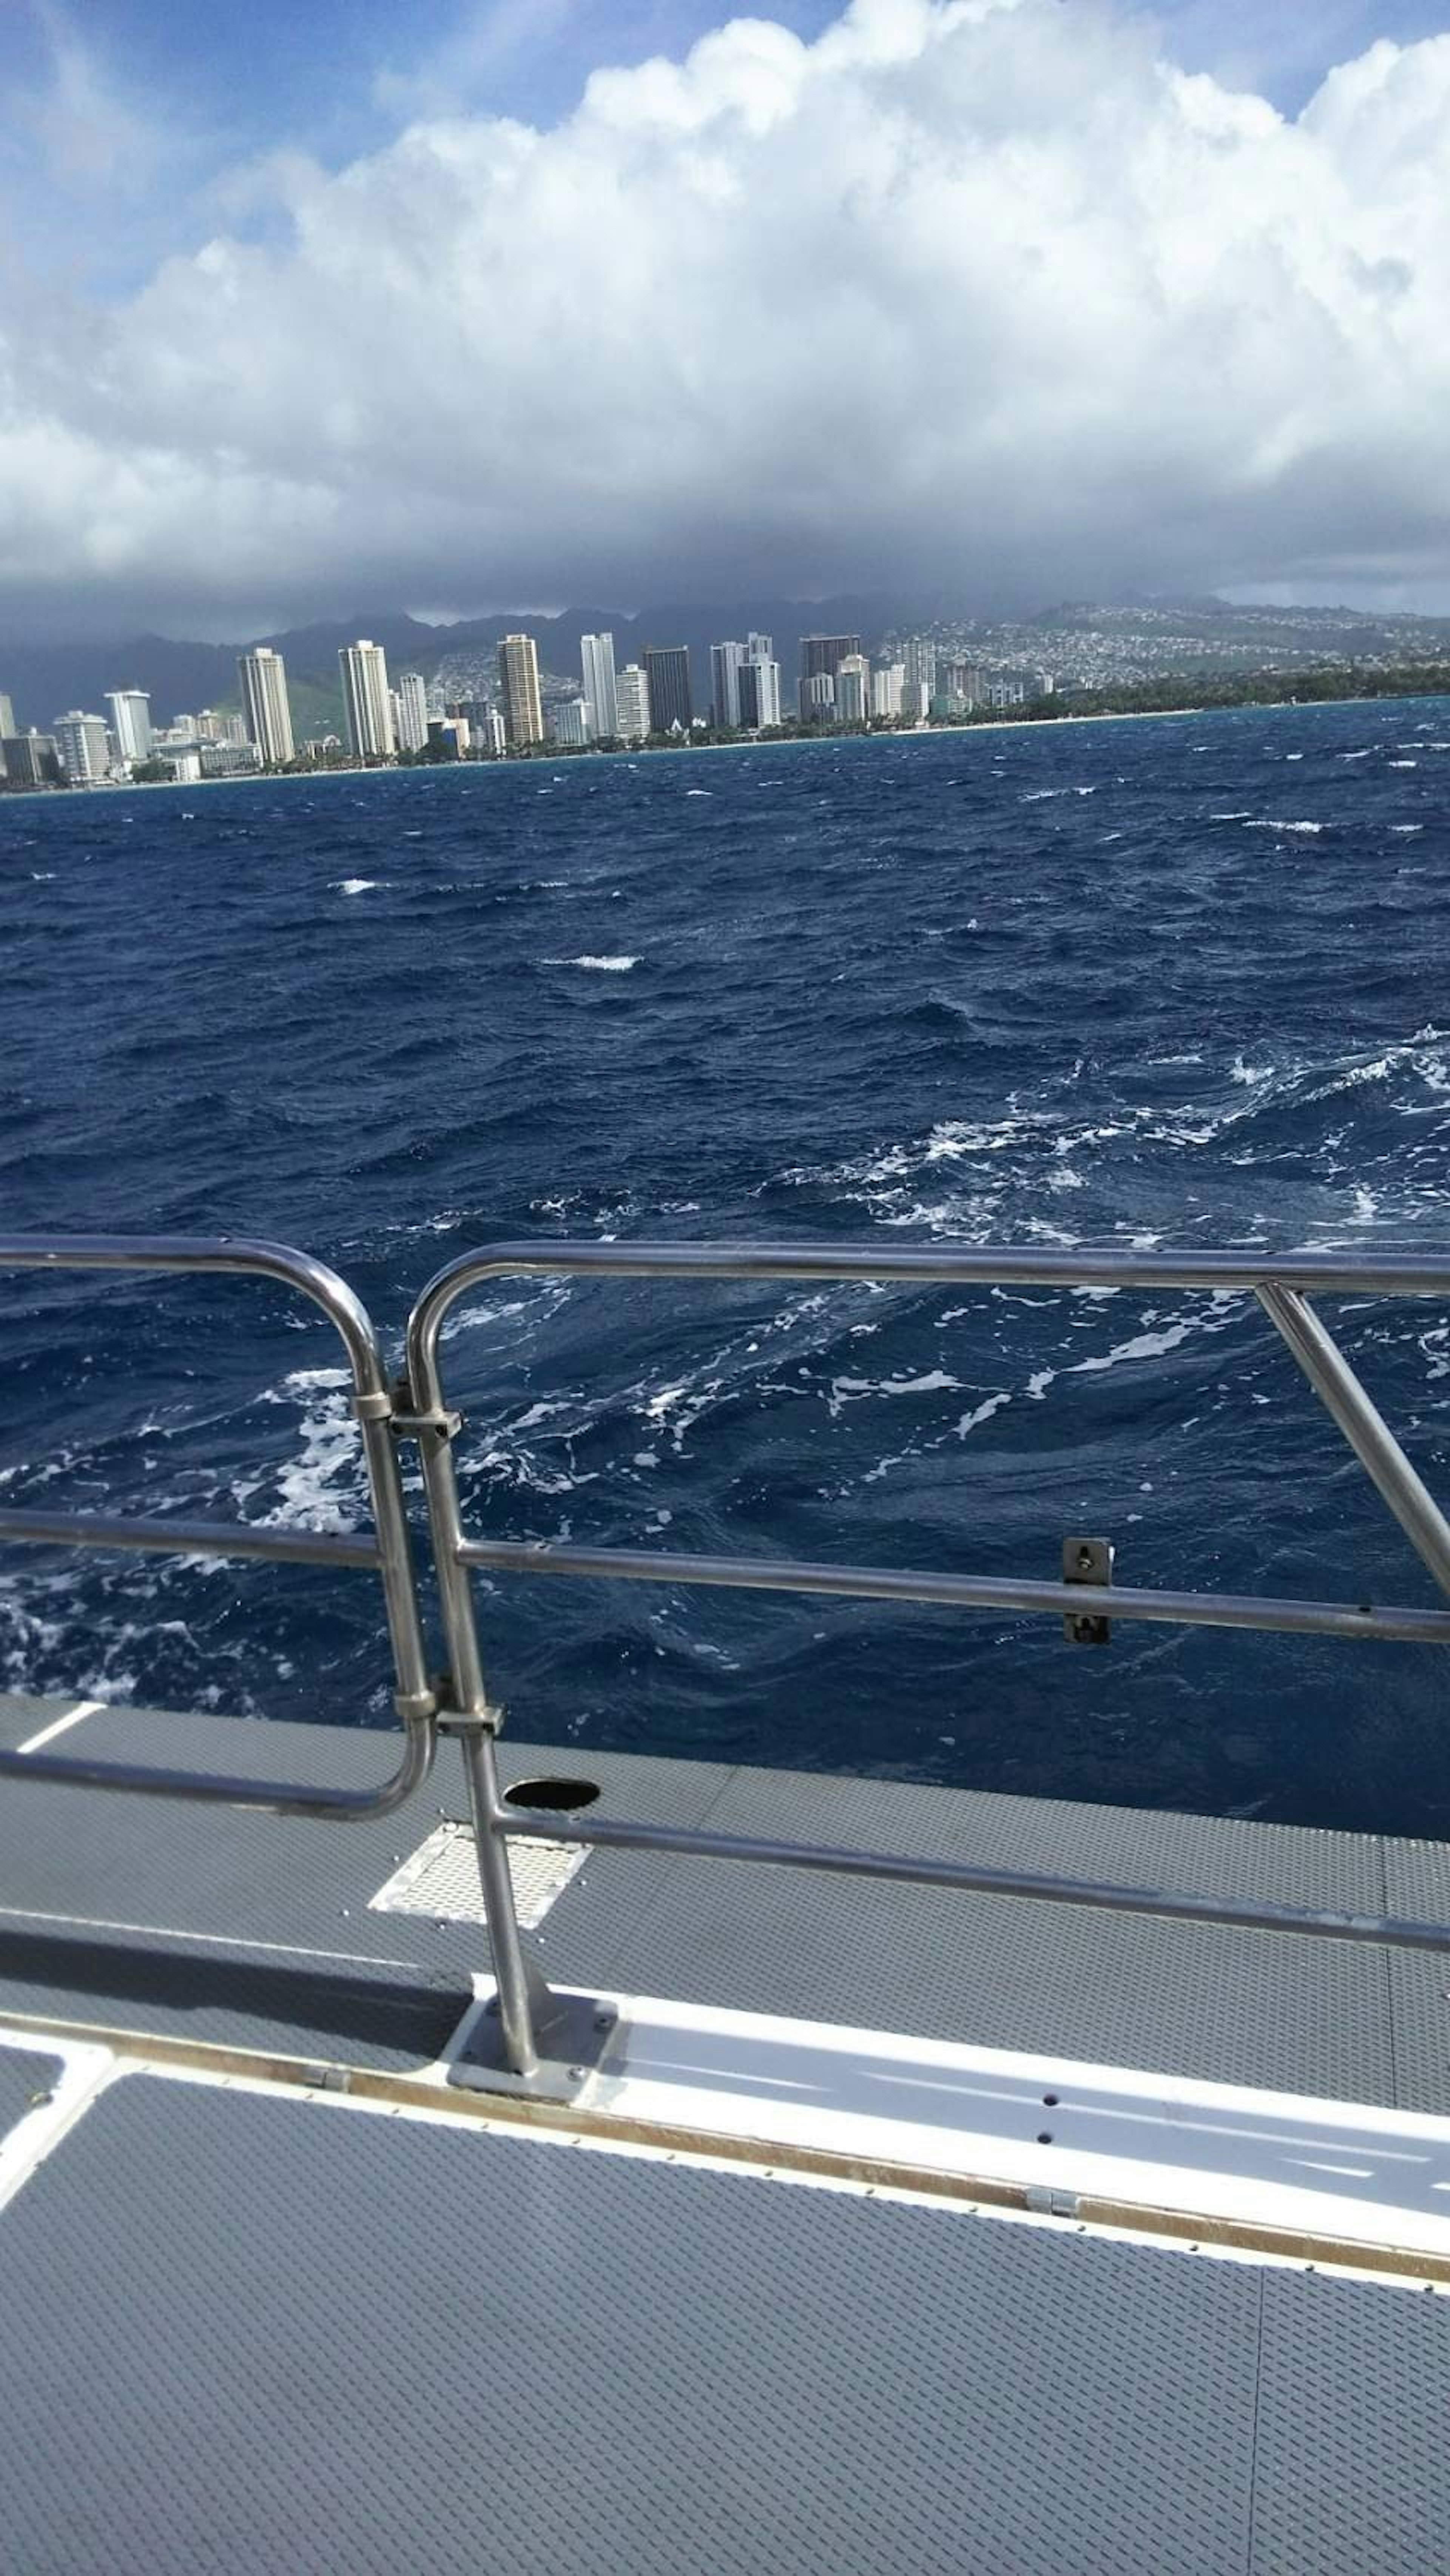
[0,1234,438,1821]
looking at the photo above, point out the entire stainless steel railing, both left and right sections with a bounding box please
[0,1234,1450,2079]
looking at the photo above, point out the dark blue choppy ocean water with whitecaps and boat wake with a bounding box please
[0,701,1450,1834]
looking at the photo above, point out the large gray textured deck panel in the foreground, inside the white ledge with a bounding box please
[0,2076,1450,2576]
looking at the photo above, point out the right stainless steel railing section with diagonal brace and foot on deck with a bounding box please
[407,1244,1450,2076]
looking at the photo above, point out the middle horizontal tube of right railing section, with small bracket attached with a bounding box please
[456,1538,1450,1646]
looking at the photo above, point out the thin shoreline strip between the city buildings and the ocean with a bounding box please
[0,688,1450,814]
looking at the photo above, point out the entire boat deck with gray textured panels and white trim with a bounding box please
[0,1700,1450,2576]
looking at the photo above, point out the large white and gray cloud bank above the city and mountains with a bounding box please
[0,0,1450,631]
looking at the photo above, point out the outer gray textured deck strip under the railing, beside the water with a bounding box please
[0,1700,1450,2110]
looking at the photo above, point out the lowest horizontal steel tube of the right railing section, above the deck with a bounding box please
[495,1806,1450,1950]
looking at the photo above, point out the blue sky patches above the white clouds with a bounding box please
[11,0,1450,294]
